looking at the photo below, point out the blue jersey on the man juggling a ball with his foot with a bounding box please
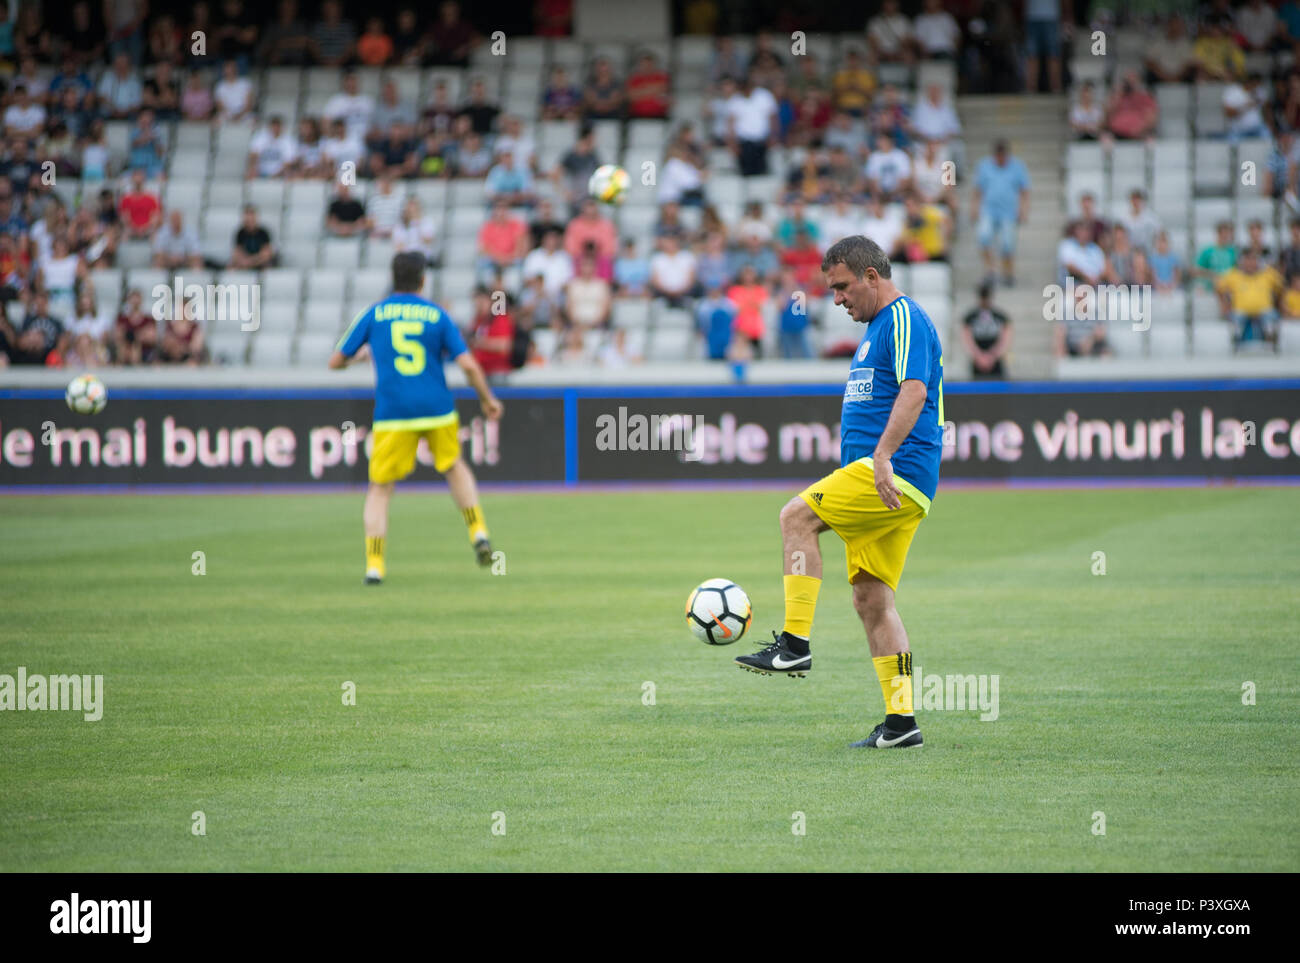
[840,296,944,513]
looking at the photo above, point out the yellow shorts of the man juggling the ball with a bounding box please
[800,460,926,589]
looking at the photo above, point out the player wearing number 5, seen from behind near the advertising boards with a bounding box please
[329,252,503,585]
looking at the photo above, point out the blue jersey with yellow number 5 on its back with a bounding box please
[338,294,467,430]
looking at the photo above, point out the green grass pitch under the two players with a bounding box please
[0,487,1300,872]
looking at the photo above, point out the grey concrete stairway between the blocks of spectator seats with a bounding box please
[944,95,1070,378]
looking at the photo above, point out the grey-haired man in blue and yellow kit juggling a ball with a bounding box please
[736,235,944,749]
